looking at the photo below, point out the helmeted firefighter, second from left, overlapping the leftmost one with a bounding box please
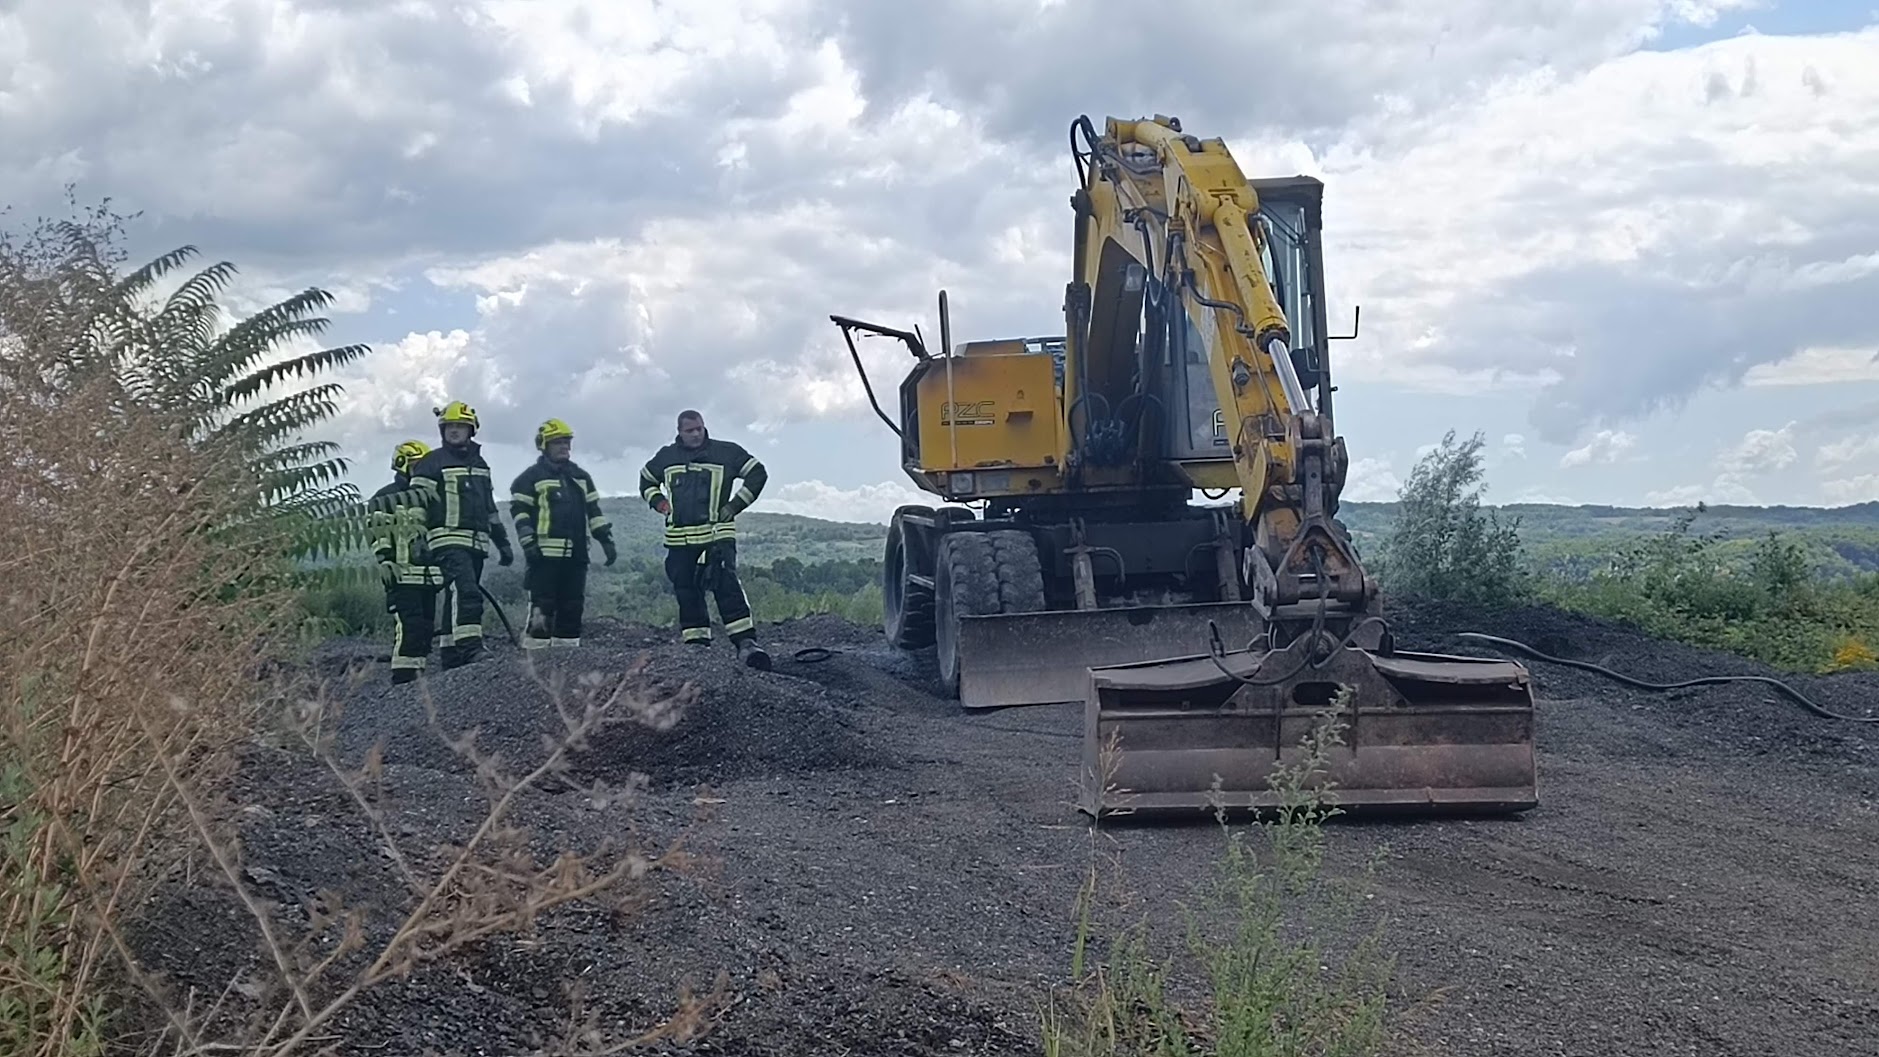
[375,400,515,670]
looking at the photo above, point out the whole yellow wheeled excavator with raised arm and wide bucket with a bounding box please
[831,115,1537,815]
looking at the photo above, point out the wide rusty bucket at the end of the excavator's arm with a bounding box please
[1080,636,1539,817]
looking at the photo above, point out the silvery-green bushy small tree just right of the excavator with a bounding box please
[1377,430,1528,605]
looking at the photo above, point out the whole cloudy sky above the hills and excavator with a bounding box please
[0,0,1879,518]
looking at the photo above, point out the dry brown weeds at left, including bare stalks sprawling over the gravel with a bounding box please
[0,202,722,1057]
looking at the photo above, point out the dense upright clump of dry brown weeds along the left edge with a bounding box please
[0,200,311,1057]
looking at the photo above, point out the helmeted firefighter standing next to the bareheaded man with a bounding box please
[509,419,620,650]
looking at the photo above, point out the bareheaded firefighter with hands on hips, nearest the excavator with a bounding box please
[639,411,770,670]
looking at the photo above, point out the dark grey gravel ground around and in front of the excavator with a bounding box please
[124,605,1879,1057]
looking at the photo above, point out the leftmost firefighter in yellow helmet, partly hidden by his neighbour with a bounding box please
[366,441,443,683]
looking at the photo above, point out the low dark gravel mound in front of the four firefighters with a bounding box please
[328,621,894,789]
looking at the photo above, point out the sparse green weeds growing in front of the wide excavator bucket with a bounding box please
[1041,691,1394,1057]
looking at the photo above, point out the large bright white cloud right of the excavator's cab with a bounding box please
[1323,28,1879,443]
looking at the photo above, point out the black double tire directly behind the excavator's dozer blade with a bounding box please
[934,529,1047,697]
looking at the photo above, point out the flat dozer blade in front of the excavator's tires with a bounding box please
[958,603,1261,708]
